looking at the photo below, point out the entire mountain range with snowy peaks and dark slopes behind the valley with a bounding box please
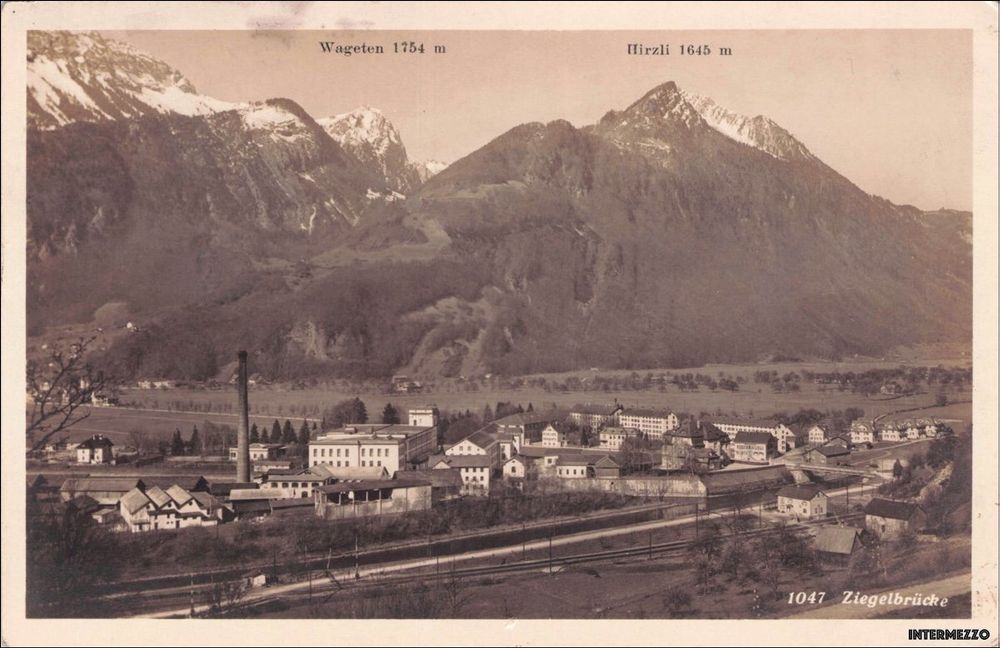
[28,35,971,378]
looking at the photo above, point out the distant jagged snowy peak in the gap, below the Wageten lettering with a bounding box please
[316,106,448,194]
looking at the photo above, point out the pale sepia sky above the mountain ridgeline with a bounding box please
[103,30,973,209]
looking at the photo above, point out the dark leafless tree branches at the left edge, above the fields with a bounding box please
[25,337,110,453]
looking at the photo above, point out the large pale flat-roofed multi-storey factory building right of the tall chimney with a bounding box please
[309,424,437,474]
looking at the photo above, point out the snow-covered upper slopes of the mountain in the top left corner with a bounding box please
[27,31,239,129]
